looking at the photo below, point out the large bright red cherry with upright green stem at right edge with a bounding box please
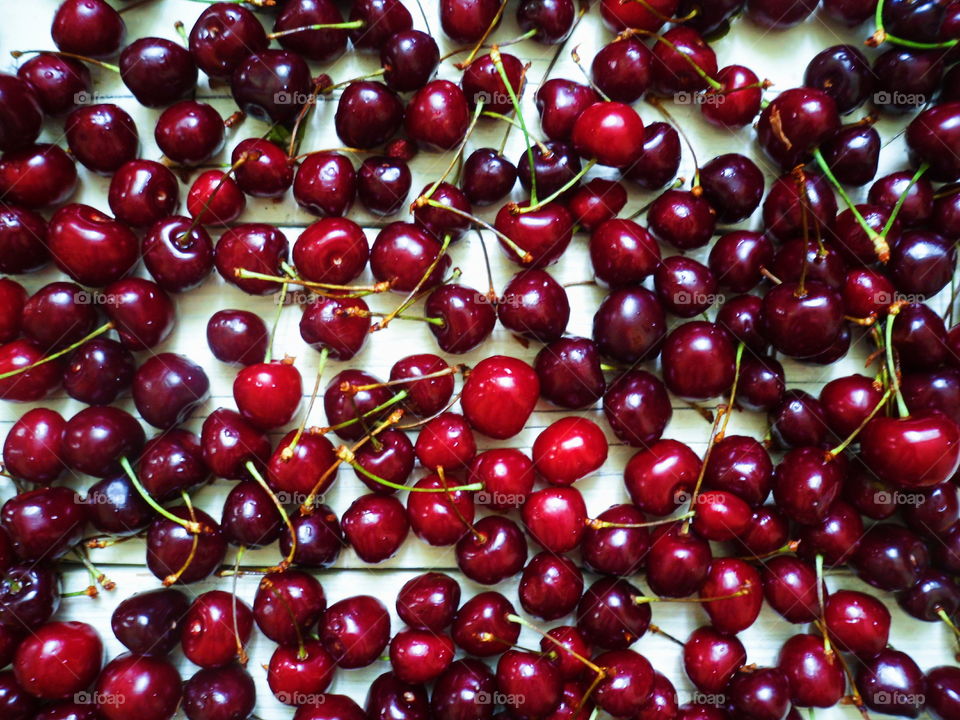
[860,412,960,488]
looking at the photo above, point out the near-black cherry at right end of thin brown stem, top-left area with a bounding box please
[119,37,197,108]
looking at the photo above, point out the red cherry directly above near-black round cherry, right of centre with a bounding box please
[590,218,660,288]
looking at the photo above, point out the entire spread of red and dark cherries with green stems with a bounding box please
[0,0,960,720]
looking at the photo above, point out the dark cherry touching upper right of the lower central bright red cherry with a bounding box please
[603,370,673,447]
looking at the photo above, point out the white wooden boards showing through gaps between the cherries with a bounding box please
[0,0,955,720]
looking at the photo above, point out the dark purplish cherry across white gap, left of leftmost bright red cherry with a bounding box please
[133,353,210,430]
